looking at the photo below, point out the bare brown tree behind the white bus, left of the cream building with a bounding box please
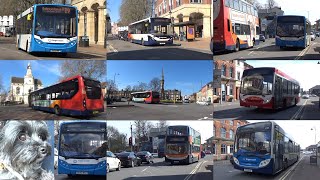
[120,0,152,26]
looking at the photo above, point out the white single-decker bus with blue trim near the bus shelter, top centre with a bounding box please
[128,17,173,46]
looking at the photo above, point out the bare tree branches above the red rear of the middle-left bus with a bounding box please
[60,60,107,80]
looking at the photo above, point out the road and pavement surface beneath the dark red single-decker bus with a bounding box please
[213,97,320,120]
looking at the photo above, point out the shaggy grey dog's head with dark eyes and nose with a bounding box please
[0,121,54,180]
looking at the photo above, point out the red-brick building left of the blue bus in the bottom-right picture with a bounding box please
[211,120,248,160]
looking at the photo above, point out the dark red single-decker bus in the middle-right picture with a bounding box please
[240,67,300,109]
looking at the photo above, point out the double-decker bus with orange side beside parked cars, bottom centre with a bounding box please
[165,126,201,164]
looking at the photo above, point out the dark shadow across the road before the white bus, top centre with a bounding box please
[107,48,213,60]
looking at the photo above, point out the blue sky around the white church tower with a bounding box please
[0,60,60,90]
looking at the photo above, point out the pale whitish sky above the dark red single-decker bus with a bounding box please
[246,60,320,91]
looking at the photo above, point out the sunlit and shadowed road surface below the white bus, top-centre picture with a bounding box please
[107,36,213,60]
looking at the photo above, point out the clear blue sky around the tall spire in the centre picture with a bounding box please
[107,60,213,95]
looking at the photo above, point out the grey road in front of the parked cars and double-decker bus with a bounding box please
[107,155,213,180]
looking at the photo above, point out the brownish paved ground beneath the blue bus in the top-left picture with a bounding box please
[0,37,107,60]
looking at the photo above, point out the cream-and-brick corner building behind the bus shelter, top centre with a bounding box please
[154,0,212,38]
